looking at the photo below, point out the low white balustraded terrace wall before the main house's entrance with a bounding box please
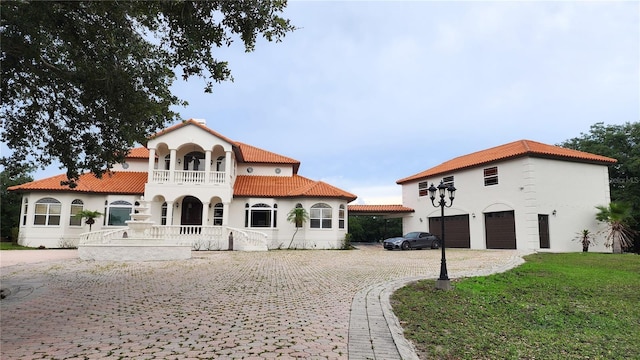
[79,225,268,251]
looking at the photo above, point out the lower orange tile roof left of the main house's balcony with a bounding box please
[8,171,147,195]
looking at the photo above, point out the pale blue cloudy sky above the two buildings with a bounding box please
[20,1,640,204]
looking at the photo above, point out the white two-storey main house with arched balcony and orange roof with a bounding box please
[9,119,356,250]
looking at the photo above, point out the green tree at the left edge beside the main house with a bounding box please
[0,170,33,242]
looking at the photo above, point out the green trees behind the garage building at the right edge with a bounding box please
[560,122,640,252]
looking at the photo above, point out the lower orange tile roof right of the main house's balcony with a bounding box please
[233,175,357,201]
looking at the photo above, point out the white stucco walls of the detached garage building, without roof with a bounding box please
[402,157,610,252]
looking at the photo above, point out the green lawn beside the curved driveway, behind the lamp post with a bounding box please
[391,253,640,359]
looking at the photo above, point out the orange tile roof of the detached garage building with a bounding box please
[396,140,617,184]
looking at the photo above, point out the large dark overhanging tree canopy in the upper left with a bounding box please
[0,0,294,186]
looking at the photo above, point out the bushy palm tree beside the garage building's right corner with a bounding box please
[596,202,634,254]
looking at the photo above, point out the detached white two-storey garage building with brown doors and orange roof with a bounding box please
[397,140,616,252]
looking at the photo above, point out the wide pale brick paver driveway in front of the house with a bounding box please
[0,245,518,359]
